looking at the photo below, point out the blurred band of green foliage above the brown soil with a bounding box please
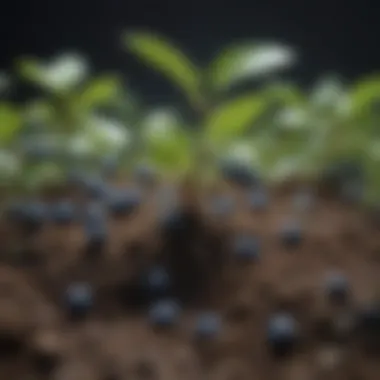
[0,31,380,200]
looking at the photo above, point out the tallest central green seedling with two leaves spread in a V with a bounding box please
[124,32,296,184]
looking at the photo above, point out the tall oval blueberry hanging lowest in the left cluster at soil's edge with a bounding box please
[84,204,108,248]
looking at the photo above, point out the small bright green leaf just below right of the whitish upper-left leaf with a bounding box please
[78,76,121,110]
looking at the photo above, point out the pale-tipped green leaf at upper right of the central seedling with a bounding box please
[208,43,296,90]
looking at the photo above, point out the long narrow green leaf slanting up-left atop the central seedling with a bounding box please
[124,32,201,102]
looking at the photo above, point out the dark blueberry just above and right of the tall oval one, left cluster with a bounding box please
[108,189,142,216]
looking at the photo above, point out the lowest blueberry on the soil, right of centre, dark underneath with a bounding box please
[267,313,299,356]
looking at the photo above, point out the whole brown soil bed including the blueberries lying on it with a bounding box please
[0,182,380,380]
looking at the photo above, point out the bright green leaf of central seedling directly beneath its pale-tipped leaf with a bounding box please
[205,94,266,149]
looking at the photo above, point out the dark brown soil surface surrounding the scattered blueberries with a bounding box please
[0,182,380,380]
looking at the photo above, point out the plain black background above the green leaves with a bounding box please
[0,0,380,102]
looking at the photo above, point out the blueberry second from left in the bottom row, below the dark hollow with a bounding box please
[149,300,181,327]
